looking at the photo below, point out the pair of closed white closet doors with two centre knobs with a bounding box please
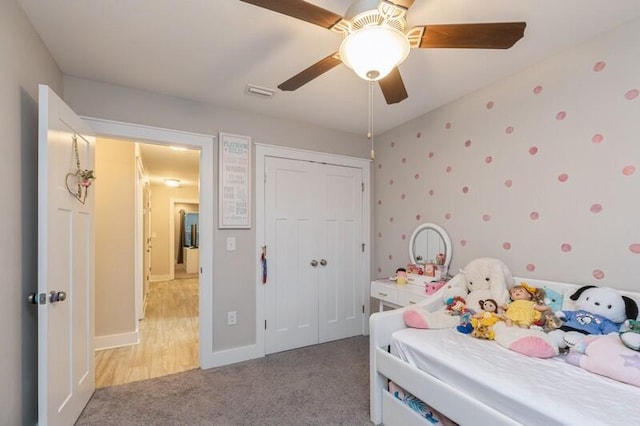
[265,157,364,354]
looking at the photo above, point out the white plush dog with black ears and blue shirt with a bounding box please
[549,285,638,348]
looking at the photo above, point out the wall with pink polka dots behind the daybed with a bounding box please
[372,22,640,291]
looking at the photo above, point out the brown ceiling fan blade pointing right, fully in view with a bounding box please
[419,22,527,49]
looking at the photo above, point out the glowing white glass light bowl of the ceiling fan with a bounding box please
[340,25,410,81]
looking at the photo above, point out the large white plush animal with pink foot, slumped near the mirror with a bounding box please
[404,258,513,328]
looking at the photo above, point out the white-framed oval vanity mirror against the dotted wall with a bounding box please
[409,223,451,269]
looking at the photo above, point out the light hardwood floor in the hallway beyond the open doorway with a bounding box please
[95,278,199,388]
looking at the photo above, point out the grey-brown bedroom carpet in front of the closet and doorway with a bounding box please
[76,336,371,426]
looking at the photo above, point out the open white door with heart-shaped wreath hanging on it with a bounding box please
[37,85,95,426]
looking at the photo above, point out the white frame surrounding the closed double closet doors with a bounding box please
[254,143,371,357]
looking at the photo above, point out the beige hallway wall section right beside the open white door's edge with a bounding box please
[95,138,136,337]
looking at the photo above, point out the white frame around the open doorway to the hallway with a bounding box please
[81,116,217,368]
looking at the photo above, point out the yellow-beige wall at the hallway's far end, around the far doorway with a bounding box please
[151,183,198,280]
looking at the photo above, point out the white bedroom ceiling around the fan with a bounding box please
[18,0,640,184]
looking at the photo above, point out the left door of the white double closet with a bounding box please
[265,158,319,354]
